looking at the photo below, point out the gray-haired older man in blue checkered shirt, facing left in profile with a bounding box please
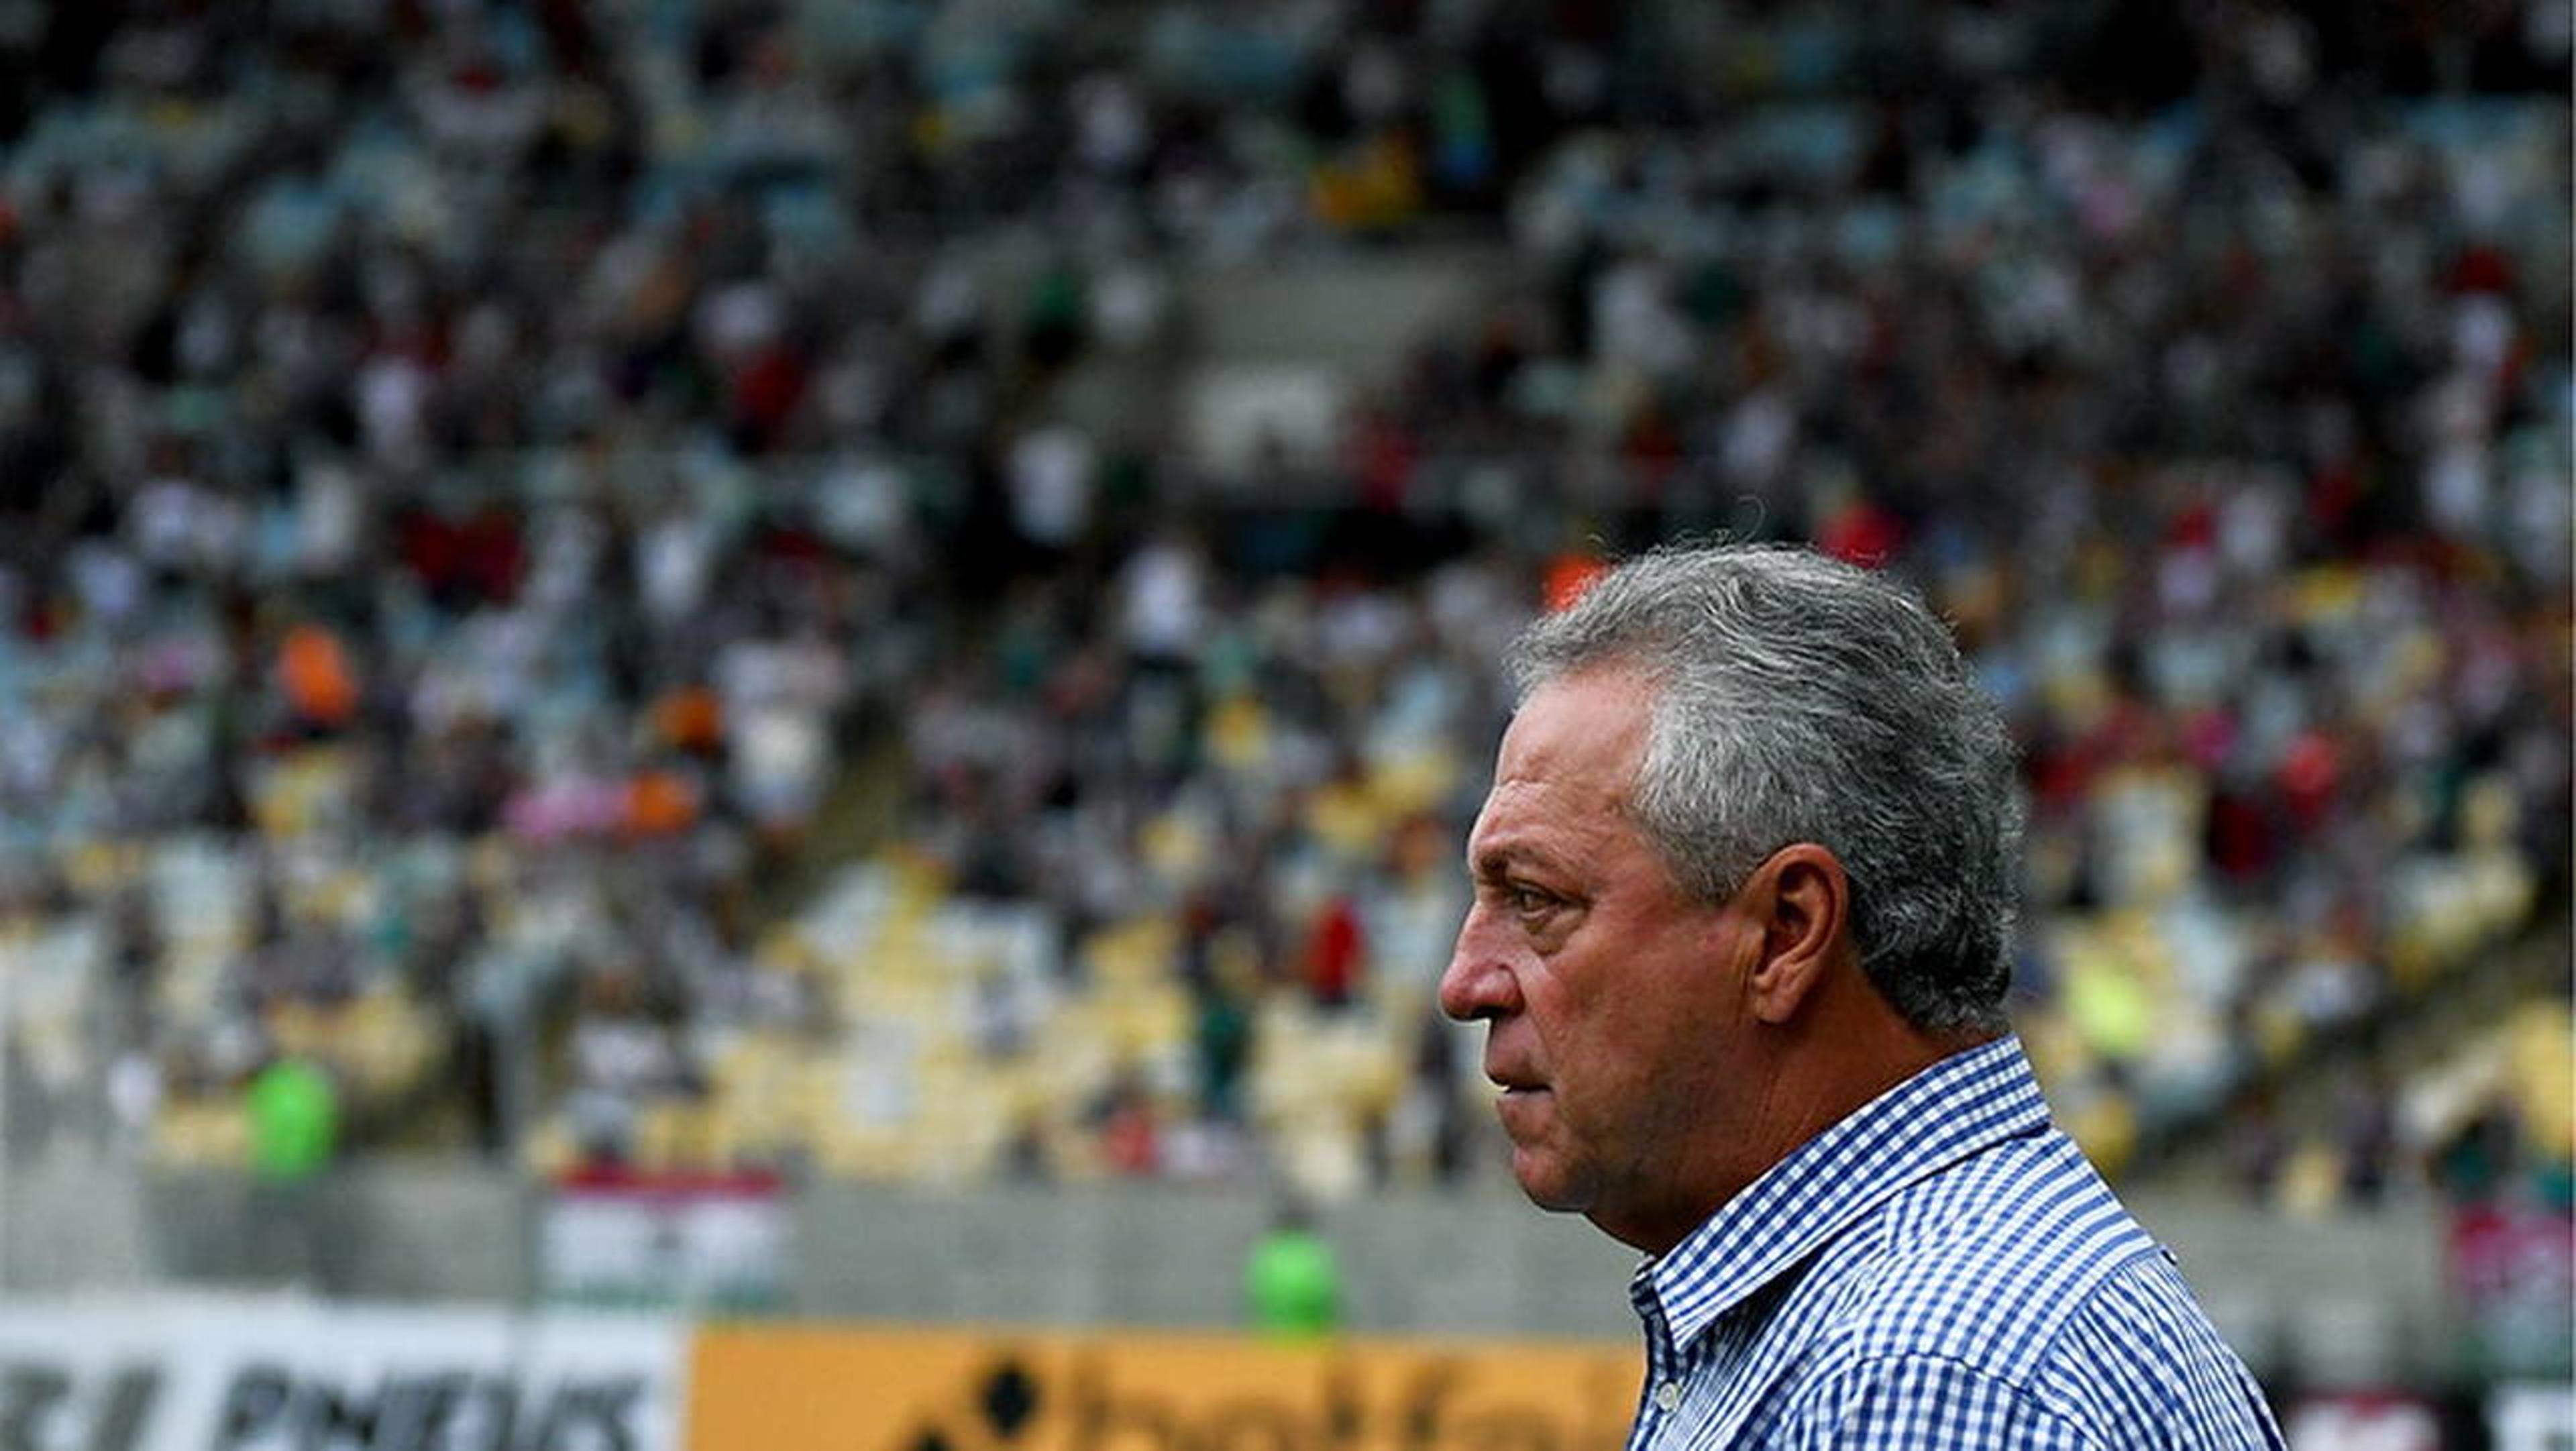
[1440,546,2282,1451]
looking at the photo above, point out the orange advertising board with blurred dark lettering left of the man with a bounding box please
[688,1325,1644,1451]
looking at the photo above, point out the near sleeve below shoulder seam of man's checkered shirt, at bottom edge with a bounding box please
[1778,1356,2110,1451]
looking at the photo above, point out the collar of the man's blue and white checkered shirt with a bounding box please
[1631,1034,2048,1348]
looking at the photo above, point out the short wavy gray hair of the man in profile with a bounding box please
[1509,544,2022,1031]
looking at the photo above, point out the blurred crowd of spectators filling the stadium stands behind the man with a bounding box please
[0,0,2576,1203]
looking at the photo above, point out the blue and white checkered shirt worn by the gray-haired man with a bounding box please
[1628,1036,2282,1451]
